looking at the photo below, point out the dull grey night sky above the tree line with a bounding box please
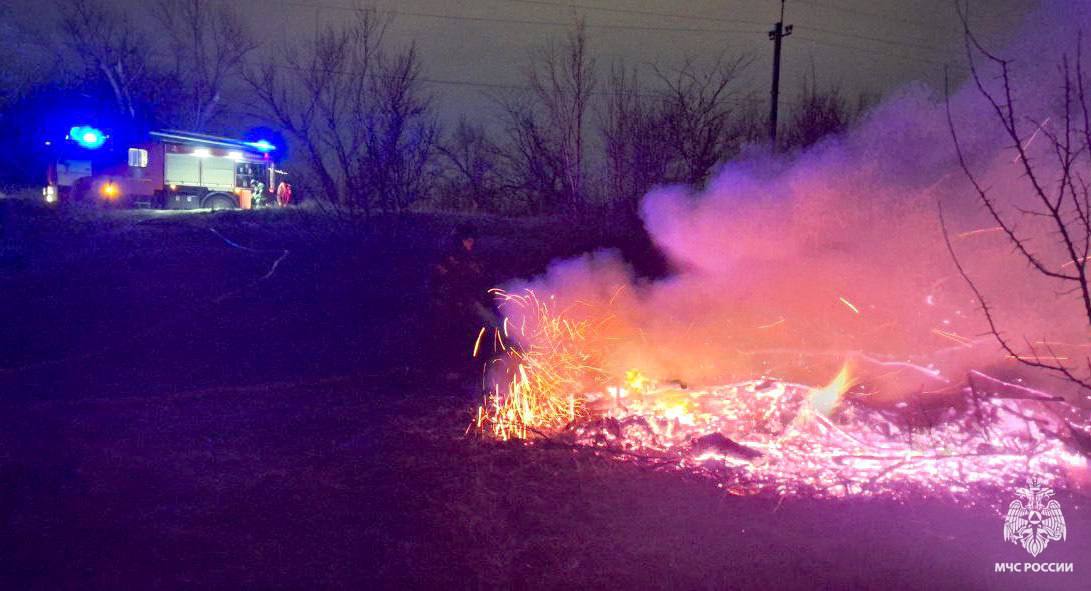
[10,0,1038,120]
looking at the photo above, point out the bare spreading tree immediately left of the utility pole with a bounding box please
[654,58,747,185]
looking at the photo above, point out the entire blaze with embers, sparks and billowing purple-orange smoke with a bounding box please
[472,4,1091,503]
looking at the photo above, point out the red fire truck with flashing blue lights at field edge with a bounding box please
[44,125,285,209]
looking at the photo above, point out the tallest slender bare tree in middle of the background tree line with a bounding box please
[505,22,596,210]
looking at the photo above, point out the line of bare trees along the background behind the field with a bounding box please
[0,0,864,215]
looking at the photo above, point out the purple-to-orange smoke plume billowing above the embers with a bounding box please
[499,2,1091,403]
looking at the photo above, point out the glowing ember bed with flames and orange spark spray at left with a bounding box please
[475,291,1087,497]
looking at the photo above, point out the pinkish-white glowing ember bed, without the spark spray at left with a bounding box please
[571,371,1086,503]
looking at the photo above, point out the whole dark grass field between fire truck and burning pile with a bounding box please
[0,203,1091,590]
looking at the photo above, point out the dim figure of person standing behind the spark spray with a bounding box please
[432,224,496,378]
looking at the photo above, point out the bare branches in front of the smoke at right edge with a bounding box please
[939,7,1091,388]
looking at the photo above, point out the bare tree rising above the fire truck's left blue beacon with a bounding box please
[60,0,153,119]
